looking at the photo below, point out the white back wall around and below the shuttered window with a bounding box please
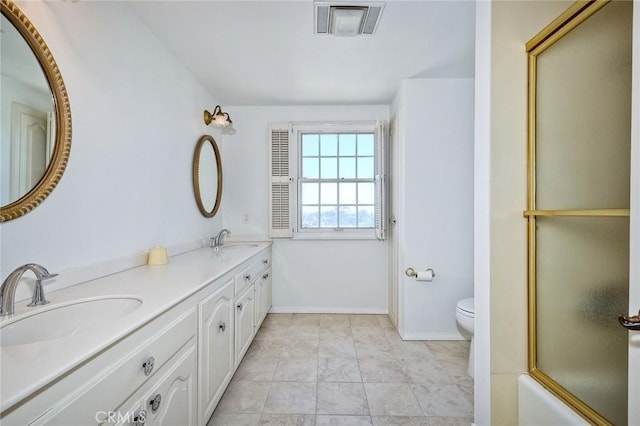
[220,105,389,313]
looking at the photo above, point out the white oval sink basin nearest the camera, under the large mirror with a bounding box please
[0,296,142,346]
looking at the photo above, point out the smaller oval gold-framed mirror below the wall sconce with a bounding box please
[193,135,222,217]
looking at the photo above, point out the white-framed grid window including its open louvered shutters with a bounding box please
[270,122,386,239]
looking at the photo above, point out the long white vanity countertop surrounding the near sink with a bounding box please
[0,243,271,411]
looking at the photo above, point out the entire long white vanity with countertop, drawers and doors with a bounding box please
[0,243,271,425]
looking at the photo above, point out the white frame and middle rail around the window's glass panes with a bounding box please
[290,121,385,240]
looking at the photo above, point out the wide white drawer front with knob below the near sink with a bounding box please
[27,307,197,425]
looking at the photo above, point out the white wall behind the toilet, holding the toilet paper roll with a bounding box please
[391,79,474,339]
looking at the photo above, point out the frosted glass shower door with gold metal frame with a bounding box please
[525,1,640,425]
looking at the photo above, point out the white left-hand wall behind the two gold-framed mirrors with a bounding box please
[1,1,224,296]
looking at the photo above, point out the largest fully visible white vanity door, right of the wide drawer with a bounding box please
[198,280,234,425]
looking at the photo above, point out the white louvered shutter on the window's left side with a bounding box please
[269,125,293,238]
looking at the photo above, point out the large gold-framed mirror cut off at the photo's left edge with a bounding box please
[0,0,71,222]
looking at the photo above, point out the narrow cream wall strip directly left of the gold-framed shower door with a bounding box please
[478,1,572,425]
